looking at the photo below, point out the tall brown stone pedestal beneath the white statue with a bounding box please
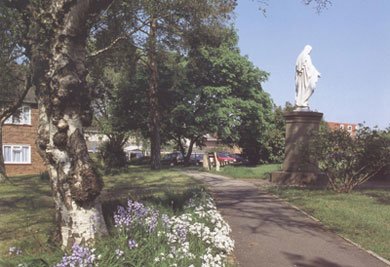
[271,111,324,185]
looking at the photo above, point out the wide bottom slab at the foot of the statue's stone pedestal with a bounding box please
[271,171,328,187]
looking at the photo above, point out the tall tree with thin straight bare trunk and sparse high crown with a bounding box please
[122,0,236,169]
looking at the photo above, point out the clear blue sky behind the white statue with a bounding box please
[235,0,390,129]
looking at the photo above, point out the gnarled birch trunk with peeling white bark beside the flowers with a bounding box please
[30,0,112,247]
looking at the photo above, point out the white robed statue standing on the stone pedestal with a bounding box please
[295,45,321,110]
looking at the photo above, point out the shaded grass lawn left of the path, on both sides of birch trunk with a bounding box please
[0,166,199,265]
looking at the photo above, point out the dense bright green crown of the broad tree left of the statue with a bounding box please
[168,28,272,164]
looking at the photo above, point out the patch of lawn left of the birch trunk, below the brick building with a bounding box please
[0,176,54,258]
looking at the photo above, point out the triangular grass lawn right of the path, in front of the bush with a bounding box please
[269,187,390,260]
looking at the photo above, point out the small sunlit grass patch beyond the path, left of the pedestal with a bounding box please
[218,164,281,179]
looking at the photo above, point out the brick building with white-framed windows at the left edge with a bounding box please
[2,92,46,176]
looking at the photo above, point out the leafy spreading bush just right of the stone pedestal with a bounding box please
[303,126,390,192]
